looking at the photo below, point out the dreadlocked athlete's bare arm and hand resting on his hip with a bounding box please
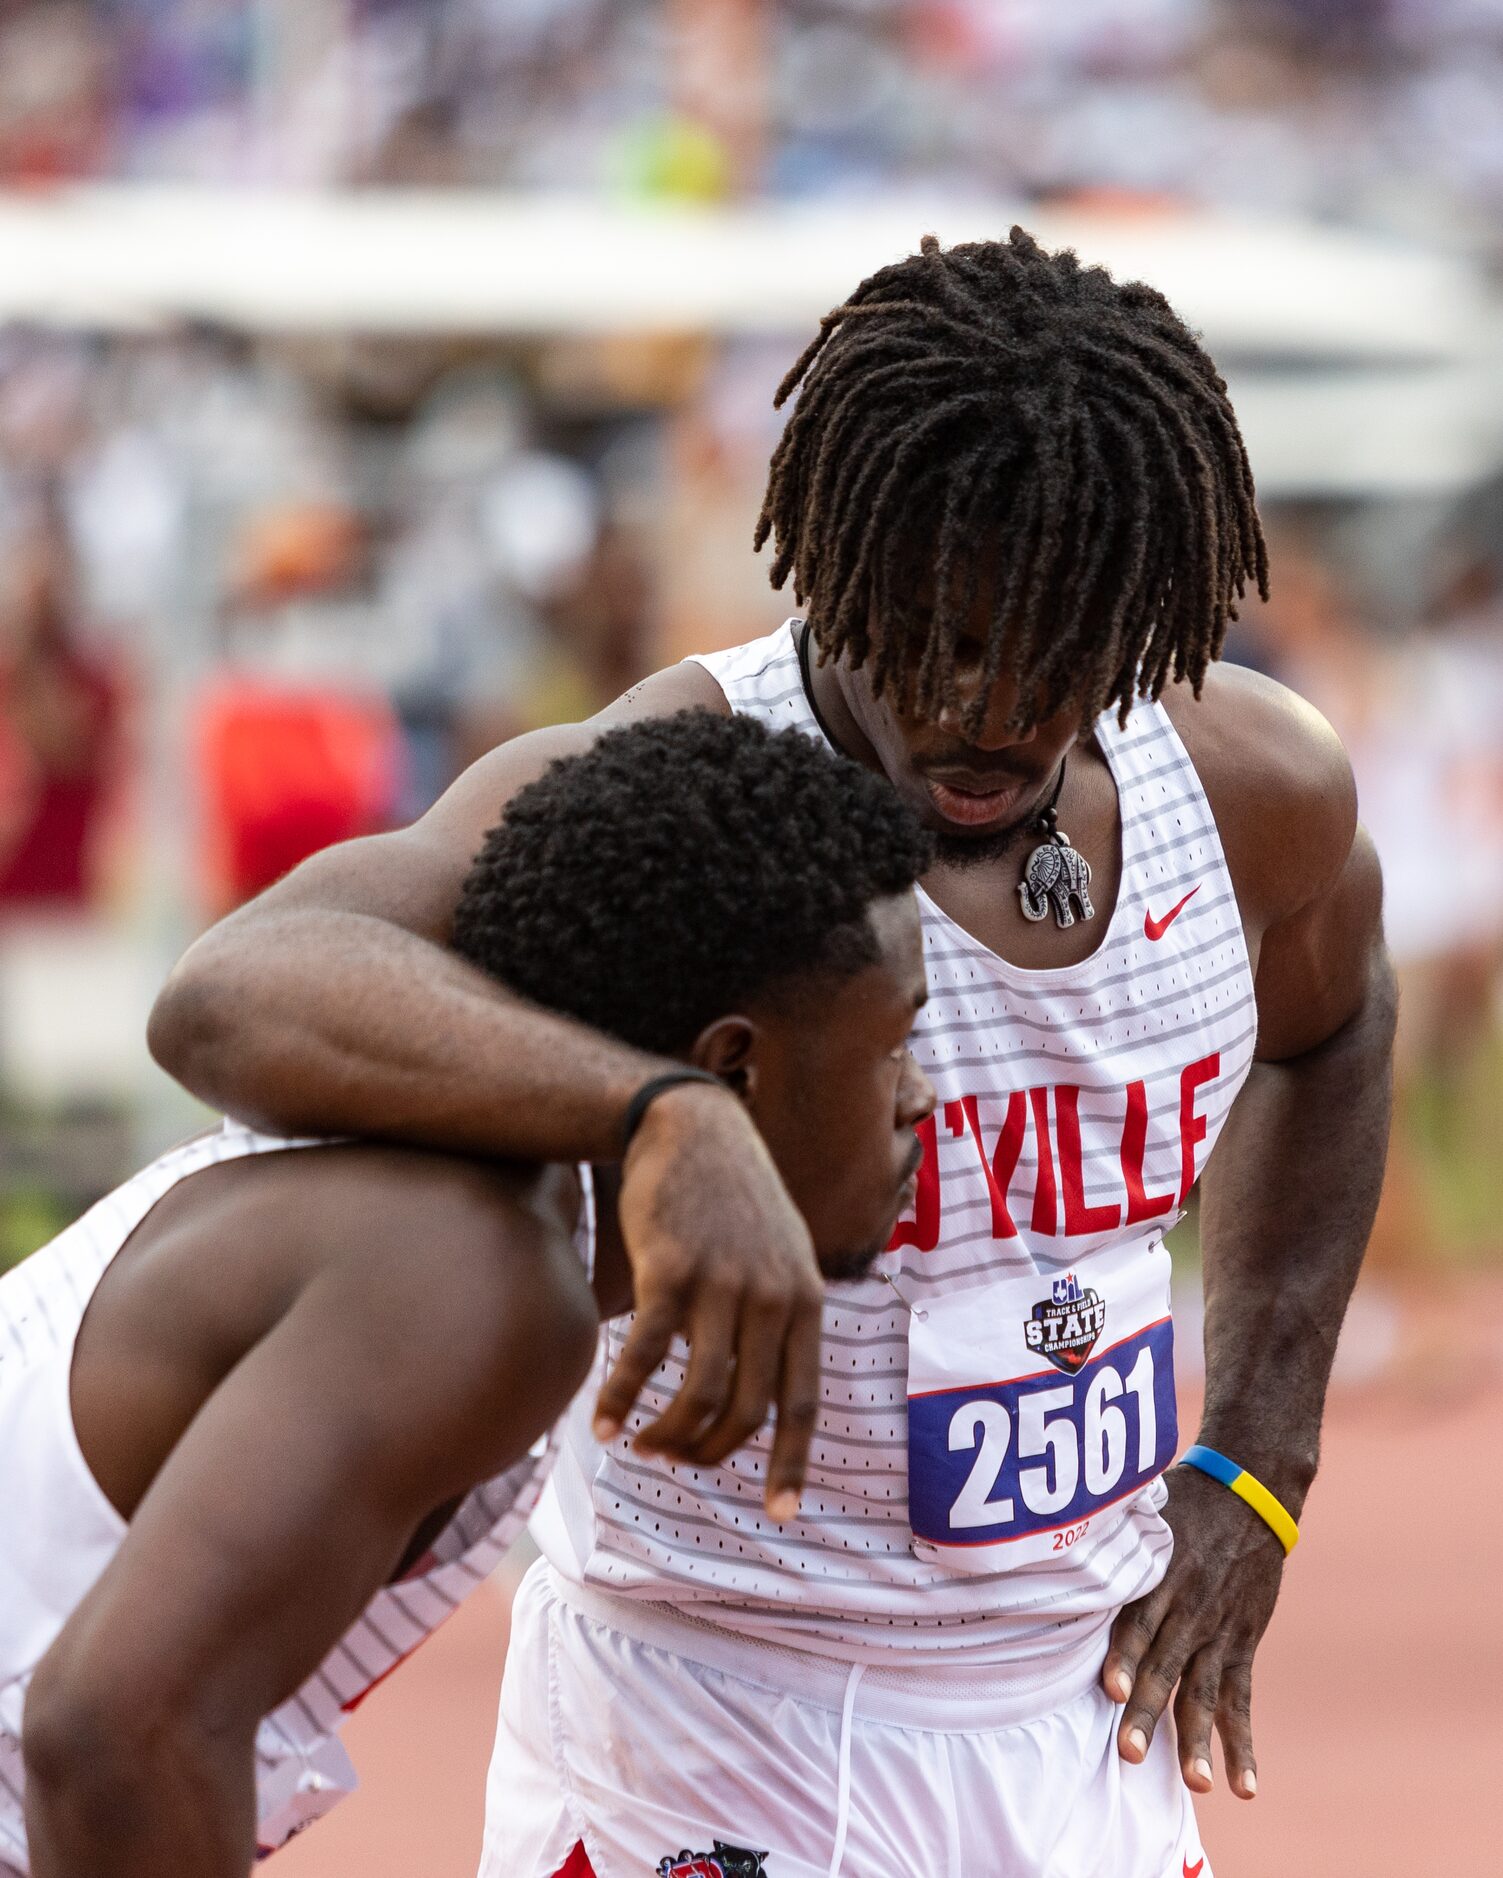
[1105,674,1396,1797]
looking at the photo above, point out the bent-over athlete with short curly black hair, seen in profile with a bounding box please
[0,712,934,1878]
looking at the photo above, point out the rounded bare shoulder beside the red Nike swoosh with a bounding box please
[1163,665,1356,933]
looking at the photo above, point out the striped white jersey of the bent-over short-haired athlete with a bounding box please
[0,1121,594,1872]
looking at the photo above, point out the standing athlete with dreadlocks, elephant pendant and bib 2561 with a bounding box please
[146,231,1392,1878]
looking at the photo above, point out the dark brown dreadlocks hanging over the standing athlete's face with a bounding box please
[755,227,1268,731]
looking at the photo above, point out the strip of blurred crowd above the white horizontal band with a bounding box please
[0,0,1503,225]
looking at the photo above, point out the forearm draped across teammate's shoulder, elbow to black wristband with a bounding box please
[150,907,665,1161]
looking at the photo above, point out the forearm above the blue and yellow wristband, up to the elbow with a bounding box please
[1201,952,1394,1517]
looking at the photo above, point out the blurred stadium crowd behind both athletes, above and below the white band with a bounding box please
[0,0,1503,1271]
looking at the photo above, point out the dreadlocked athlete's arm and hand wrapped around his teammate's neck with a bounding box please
[150,665,823,1519]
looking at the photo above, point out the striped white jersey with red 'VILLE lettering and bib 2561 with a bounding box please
[534,622,1255,1686]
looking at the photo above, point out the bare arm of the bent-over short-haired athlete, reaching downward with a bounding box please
[23,1168,594,1878]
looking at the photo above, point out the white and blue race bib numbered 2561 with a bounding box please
[907,1239,1180,1572]
